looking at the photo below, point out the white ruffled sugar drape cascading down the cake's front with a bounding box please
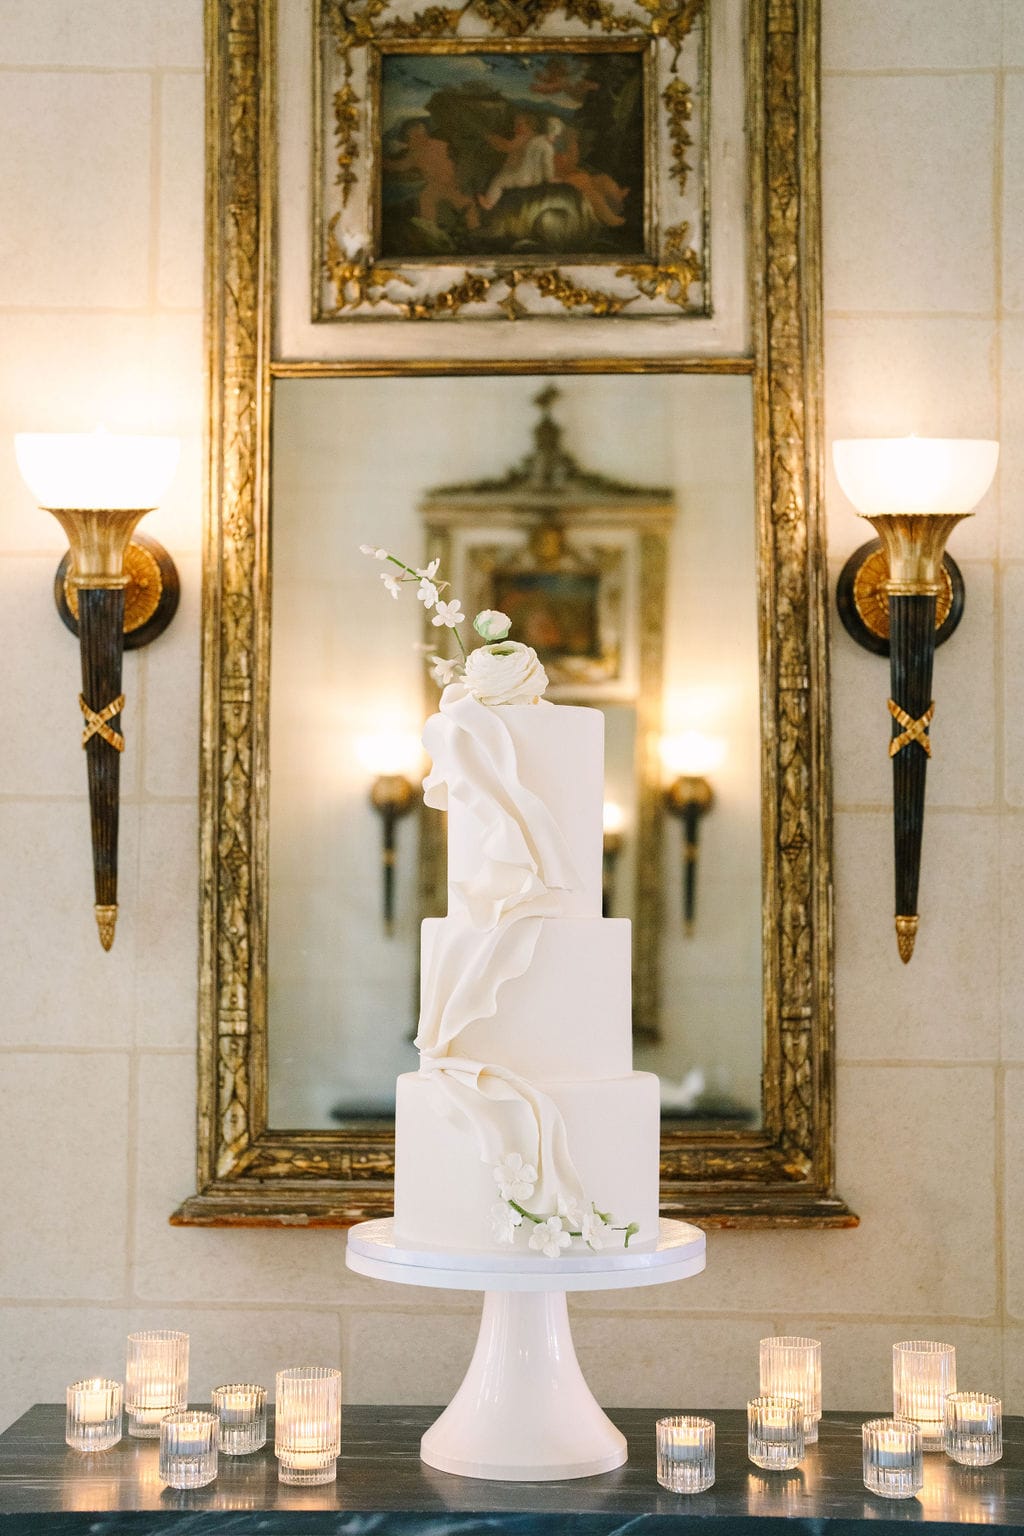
[416,684,583,1210]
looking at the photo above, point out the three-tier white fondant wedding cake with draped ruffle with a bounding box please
[395,685,659,1253]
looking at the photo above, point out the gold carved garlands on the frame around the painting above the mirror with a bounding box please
[313,0,706,321]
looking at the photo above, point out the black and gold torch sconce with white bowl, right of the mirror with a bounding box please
[832,438,999,965]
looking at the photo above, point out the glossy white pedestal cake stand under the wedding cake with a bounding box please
[345,1217,705,1482]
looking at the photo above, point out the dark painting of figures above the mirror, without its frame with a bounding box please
[378,45,648,261]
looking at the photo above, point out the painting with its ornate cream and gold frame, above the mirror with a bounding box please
[313,0,711,321]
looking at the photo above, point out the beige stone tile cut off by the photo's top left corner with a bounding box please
[0,0,203,69]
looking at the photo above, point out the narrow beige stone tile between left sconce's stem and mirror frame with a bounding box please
[143,541,203,797]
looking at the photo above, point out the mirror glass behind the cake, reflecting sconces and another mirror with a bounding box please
[267,375,761,1129]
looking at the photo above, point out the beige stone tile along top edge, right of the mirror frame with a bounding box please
[821,0,1018,69]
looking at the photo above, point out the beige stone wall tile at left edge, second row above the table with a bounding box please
[0,1056,129,1296]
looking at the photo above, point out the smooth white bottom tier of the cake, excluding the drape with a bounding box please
[395,1072,660,1253]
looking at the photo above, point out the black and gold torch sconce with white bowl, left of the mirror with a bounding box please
[14,432,178,949]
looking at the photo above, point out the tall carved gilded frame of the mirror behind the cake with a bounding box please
[172,0,857,1227]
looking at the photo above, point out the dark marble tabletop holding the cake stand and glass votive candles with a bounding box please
[0,1404,1024,1536]
